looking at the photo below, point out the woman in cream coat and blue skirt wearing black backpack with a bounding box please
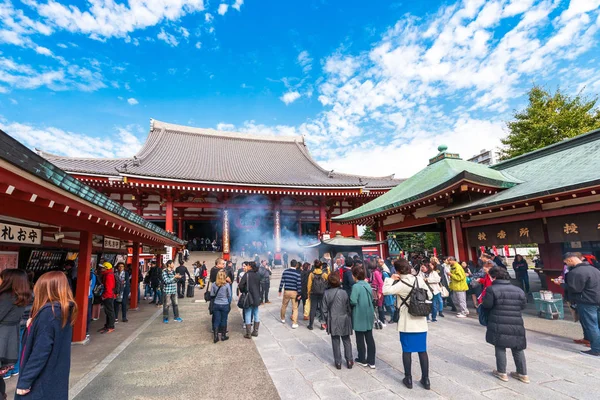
[383,259,433,390]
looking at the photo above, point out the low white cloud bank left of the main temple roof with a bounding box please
[0,118,143,158]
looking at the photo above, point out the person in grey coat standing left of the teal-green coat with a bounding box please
[323,274,354,369]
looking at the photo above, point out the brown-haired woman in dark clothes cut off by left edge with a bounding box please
[0,268,31,399]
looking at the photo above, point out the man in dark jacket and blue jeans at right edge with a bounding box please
[564,253,600,357]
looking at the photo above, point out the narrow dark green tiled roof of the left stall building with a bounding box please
[0,130,185,244]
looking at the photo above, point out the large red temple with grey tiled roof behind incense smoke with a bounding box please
[39,120,402,260]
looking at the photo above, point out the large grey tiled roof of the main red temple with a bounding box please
[40,120,402,189]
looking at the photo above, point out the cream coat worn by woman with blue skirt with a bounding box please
[383,275,433,333]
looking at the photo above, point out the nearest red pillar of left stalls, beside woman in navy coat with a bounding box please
[73,232,92,343]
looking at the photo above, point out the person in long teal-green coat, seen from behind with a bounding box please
[350,265,375,369]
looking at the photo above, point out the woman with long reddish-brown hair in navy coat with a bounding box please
[15,271,77,400]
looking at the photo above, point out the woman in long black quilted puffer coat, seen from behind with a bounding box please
[481,267,529,383]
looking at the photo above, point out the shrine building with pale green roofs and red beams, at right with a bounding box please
[333,130,600,292]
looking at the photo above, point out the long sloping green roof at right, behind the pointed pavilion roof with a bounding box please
[435,129,600,216]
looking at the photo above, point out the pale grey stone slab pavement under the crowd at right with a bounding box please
[255,273,600,400]
